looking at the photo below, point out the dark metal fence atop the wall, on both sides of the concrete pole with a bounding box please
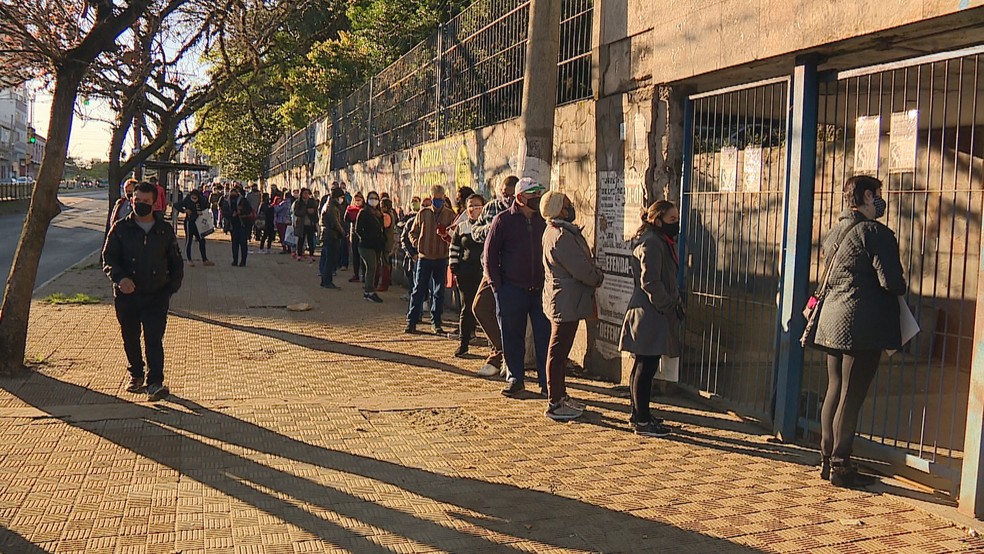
[304,0,594,173]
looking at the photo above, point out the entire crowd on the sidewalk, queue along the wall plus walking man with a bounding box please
[103,171,906,487]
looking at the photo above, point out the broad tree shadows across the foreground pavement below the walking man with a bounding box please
[0,373,757,554]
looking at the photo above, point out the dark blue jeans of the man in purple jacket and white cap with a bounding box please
[495,283,550,391]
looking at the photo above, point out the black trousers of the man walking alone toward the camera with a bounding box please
[115,292,171,385]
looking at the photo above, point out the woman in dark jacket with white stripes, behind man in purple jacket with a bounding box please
[450,194,485,357]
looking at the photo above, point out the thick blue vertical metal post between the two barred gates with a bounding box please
[773,56,819,441]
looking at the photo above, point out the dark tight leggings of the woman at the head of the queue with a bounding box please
[820,350,881,462]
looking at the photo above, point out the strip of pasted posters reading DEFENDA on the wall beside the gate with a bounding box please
[595,171,642,359]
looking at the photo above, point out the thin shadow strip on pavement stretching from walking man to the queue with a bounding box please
[170,309,475,377]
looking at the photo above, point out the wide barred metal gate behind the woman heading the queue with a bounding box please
[800,48,984,486]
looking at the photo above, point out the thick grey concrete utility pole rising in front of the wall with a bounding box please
[519,0,561,188]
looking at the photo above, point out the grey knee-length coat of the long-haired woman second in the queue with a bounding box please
[618,229,681,357]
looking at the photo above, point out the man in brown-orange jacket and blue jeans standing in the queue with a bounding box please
[403,185,456,335]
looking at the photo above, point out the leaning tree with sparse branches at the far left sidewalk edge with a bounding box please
[0,0,176,373]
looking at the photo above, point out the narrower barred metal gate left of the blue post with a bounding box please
[680,79,788,419]
